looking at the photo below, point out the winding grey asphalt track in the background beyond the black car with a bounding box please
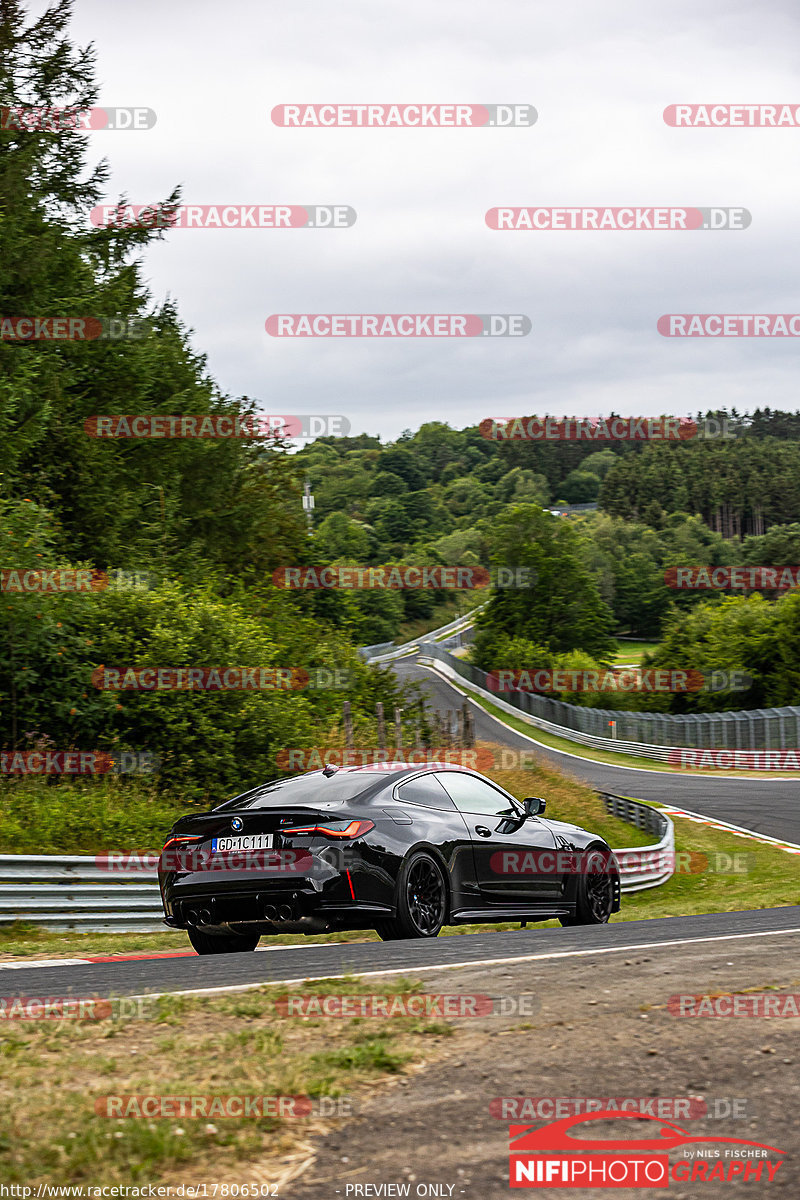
[392,658,800,842]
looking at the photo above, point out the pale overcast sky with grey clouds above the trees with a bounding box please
[53,0,800,438]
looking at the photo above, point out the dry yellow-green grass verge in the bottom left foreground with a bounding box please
[0,979,453,1195]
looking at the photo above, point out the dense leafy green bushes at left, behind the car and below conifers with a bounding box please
[0,564,412,800]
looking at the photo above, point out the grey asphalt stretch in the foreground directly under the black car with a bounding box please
[0,906,800,998]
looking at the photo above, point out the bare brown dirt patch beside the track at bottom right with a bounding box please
[288,935,800,1200]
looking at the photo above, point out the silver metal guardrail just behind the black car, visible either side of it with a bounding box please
[0,794,675,932]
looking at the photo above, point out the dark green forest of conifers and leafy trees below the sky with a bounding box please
[0,2,800,792]
